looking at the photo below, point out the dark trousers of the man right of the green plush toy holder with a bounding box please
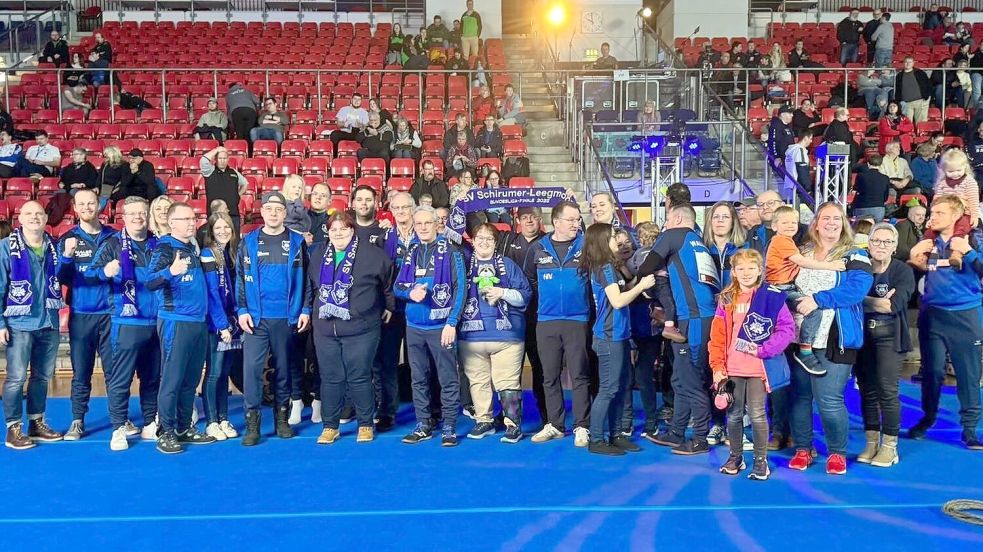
[536,320,591,431]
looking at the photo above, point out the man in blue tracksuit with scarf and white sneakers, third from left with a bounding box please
[93,196,160,450]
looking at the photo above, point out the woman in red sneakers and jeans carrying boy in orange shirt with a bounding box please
[789,203,873,475]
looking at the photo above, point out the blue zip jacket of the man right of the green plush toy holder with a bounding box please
[524,232,591,322]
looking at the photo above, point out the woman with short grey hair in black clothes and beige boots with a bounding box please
[854,223,915,468]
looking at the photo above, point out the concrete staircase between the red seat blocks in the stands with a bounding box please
[502,35,588,223]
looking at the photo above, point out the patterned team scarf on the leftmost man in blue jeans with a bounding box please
[3,228,65,316]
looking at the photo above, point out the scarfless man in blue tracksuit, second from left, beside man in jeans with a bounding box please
[58,188,115,441]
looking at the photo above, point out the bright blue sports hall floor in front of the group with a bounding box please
[0,383,983,552]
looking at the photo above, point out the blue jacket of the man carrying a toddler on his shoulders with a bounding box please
[921,236,983,311]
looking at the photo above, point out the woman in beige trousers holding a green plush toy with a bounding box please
[458,223,532,443]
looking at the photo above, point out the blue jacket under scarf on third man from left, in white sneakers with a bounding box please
[88,232,157,326]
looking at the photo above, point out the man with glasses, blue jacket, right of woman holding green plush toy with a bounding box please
[523,201,591,447]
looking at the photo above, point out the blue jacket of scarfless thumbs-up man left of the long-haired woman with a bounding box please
[147,236,211,322]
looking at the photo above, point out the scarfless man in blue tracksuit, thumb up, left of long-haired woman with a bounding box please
[147,203,223,454]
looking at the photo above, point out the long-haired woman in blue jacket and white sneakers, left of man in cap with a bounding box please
[201,212,242,441]
